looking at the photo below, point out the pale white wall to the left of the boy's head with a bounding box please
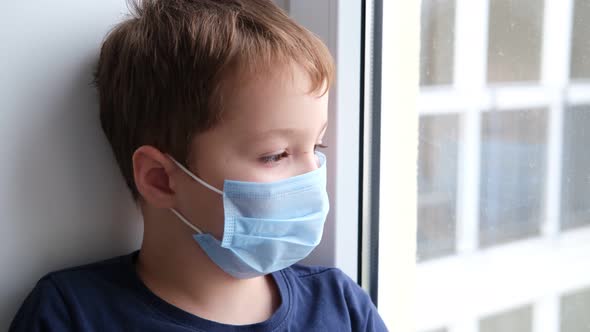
[0,0,141,331]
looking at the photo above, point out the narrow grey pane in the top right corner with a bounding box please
[570,0,590,78]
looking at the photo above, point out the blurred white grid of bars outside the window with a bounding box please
[415,0,590,332]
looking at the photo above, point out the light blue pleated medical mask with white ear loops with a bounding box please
[171,152,329,279]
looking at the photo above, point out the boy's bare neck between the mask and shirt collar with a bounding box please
[136,221,281,325]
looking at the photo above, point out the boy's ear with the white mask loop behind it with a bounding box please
[132,145,175,208]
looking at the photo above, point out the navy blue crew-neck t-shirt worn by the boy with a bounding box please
[10,251,387,332]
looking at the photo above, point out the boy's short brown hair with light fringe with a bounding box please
[94,0,334,200]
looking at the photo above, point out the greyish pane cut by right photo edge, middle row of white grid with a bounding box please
[561,106,590,229]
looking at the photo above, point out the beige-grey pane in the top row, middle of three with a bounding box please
[488,0,544,83]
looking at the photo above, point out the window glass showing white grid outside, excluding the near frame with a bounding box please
[412,0,590,332]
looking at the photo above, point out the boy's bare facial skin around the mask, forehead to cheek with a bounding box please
[174,66,328,238]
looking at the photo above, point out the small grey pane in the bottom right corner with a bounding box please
[560,287,590,332]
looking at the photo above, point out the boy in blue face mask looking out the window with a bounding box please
[10,0,386,331]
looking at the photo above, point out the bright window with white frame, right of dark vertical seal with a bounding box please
[368,0,590,332]
